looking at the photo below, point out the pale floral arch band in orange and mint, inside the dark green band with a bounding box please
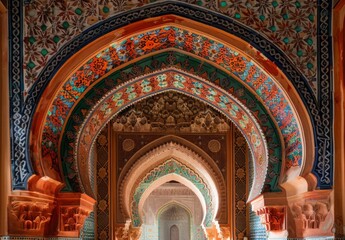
[73,70,268,199]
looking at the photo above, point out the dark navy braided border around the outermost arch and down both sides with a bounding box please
[6,1,332,199]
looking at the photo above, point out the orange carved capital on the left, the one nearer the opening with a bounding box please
[58,193,95,237]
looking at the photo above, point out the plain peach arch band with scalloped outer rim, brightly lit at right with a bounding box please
[119,141,225,223]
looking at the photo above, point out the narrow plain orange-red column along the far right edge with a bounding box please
[333,0,345,237]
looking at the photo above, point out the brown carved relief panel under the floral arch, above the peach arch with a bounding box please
[113,92,229,134]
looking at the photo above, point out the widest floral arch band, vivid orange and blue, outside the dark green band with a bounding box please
[42,27,302,186]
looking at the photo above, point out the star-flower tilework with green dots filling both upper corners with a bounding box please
[23,0,317,95]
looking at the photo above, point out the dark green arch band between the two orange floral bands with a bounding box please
[56,51,282,194]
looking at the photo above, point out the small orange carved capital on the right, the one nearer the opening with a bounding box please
[255,206,286,232]
